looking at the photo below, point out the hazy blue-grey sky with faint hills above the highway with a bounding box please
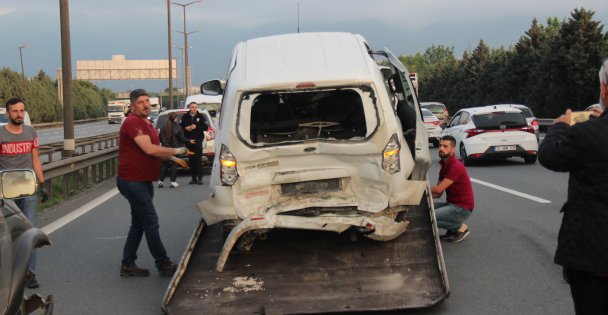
[0,0,608,92]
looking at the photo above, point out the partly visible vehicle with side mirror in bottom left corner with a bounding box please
[0,170,53,315]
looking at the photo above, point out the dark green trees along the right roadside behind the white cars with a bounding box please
[399,8,608,117]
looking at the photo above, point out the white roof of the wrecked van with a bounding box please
[231,32,377,90]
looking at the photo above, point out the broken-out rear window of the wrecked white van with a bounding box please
[239,88,377,144]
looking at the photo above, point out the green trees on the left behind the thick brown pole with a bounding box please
[0,68,115,123]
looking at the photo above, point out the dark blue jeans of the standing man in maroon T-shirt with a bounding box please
[116,177,169,268]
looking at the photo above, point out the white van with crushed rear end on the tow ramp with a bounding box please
[198,33,431,271]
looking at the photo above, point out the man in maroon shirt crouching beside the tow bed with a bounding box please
[431,136,475,243]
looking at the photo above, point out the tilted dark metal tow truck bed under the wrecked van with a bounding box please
[162,197,449,314]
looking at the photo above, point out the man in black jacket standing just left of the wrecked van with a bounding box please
[180,102,208,185]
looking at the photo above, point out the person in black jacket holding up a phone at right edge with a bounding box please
[538,60,608,314]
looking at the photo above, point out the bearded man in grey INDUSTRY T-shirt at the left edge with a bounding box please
[0,98,48,289]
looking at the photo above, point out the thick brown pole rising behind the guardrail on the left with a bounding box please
[59,0,76,157]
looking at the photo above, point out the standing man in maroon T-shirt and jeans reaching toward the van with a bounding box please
[116,89,186,277]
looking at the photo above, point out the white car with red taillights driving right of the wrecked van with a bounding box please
[442,106,538,165]
